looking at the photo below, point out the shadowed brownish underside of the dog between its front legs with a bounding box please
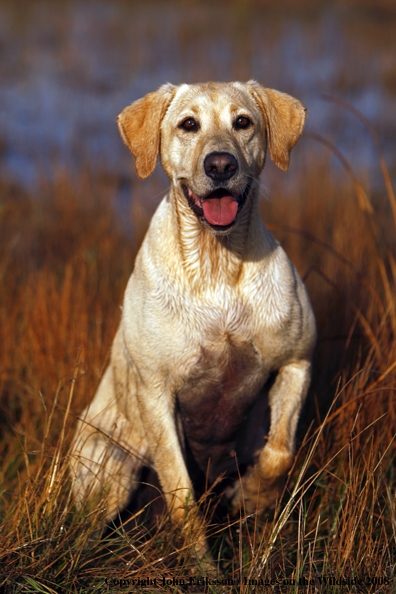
[177,342,268,470]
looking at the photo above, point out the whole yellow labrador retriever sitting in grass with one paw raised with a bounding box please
[72,81,316,555]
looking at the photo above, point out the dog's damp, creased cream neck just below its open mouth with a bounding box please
[170,183,260,290]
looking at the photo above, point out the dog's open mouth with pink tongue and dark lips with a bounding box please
[182,183,250,230]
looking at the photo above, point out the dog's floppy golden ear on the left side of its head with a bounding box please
[117,84,175,179]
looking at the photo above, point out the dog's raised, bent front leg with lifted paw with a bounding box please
[233,360,311,513]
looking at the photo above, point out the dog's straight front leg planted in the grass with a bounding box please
[138,382,214,570]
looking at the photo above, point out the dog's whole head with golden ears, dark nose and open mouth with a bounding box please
[117,81,306,234]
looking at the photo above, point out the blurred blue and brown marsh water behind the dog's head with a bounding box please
[0,0,396,192]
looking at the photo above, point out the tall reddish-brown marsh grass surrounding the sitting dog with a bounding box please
[0,113,396,593]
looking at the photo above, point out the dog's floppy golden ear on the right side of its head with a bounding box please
[247,80,307,171]
